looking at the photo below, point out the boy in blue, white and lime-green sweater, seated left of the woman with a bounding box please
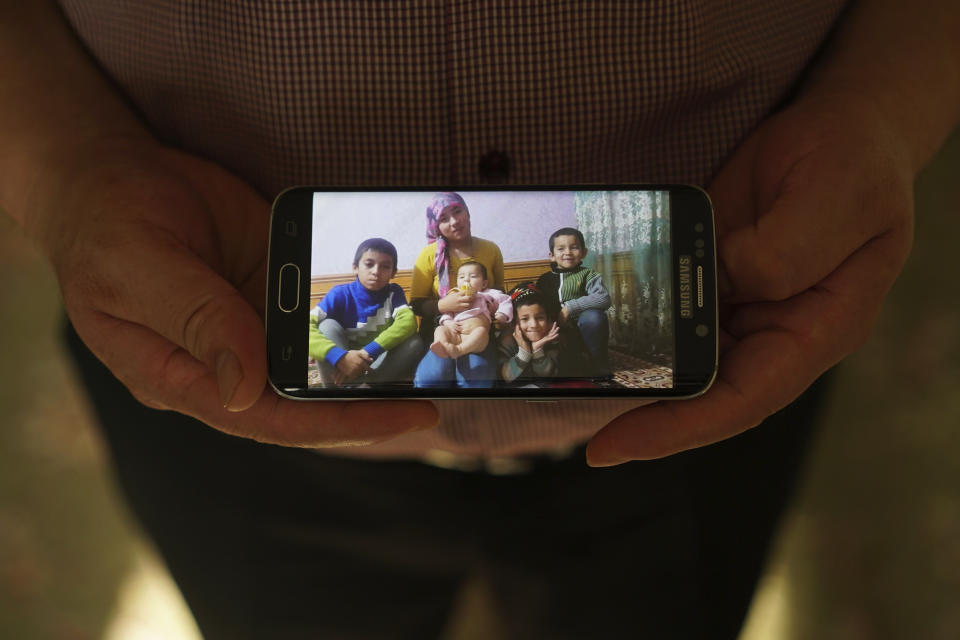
[309,238,425,386]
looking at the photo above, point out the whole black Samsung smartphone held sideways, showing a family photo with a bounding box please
[266,185,717,400]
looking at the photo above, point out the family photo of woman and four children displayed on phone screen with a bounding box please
[307,191,674,389]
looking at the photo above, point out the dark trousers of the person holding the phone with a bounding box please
[67,330,822,639]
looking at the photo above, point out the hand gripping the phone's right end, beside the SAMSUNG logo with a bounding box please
[587,95,914,466]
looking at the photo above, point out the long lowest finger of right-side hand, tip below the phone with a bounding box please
[587,225,909,466]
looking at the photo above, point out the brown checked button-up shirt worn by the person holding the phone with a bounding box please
[60,0,845,455]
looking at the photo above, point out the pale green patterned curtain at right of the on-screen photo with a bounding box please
[574,191,674,365]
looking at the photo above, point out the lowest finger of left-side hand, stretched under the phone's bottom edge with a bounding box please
[78,319,438,447]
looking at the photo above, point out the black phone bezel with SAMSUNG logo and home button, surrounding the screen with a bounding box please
[264,184,718,400]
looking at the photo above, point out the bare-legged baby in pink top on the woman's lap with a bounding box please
[430,260,513,358]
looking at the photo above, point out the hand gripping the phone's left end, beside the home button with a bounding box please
[34,142,436,446]
